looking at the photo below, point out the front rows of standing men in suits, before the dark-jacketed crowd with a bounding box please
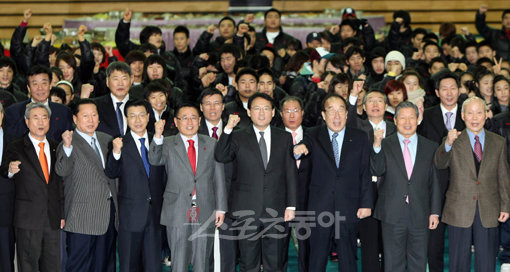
[0,60,510,271]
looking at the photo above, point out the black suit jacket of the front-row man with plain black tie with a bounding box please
[214,125,297,219]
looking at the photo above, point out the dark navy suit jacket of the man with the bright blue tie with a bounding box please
[105,130,166,232]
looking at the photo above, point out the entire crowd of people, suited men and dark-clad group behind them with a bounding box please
[0,5,510,272]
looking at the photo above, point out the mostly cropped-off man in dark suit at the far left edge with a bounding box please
[0,103,15,272]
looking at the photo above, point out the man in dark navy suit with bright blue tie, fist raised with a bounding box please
[105,101,166,271]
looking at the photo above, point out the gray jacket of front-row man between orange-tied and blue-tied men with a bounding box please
[55,130,118,235]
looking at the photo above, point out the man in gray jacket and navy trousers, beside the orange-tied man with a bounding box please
[55,99,118,272]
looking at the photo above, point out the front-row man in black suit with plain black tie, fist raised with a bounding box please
[215,92,297,271]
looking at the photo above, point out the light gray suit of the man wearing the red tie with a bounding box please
[149,134,227,271]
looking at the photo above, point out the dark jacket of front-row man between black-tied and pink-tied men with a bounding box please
[303,125,374,223]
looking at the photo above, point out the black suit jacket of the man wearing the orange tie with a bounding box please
[0,135,64,230]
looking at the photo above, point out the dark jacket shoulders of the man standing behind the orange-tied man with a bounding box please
[4,99,73,142]
